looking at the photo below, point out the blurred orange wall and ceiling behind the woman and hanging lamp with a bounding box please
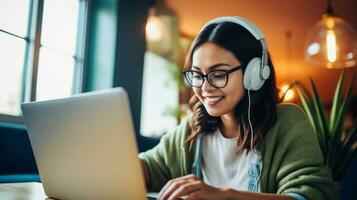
[165,0,357,103]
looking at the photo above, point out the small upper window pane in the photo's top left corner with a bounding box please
[0,0,30,37]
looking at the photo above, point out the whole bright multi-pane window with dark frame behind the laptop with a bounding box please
[0,0,86,120]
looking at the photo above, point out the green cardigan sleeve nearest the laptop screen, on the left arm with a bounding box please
[139,119,189,191]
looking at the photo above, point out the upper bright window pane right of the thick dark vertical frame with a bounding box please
[41,0,79,55]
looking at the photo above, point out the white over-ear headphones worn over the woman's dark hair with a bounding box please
[200,16,270,91]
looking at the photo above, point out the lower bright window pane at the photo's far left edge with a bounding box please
[0,32,26,115]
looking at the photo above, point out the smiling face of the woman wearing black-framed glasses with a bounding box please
[191,42,244,117]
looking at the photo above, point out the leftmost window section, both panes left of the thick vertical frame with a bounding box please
[0,0,30,115]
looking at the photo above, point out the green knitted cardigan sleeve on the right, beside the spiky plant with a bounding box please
[274,106,336,200]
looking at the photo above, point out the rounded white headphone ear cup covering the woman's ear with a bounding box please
[243,57,265,91]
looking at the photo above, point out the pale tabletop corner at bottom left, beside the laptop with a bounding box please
[0,182,51,200]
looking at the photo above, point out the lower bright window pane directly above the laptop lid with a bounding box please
[36,47,75,100]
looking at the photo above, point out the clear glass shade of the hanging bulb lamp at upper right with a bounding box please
[305,14,357,68]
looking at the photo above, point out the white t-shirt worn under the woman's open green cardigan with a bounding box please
[201,129,262,192]
